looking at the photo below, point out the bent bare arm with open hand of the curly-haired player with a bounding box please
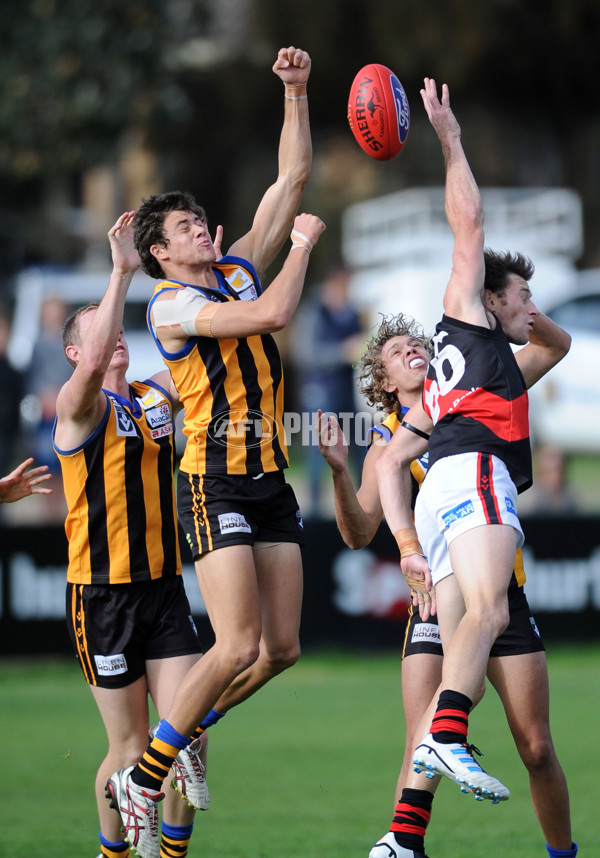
[316,409,386,549]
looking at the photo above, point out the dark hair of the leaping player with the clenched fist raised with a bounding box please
[133,191,206,280]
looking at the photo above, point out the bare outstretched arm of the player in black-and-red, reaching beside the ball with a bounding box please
[421,77,489,327]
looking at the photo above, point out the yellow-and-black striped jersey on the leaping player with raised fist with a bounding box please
[148,256,289,482]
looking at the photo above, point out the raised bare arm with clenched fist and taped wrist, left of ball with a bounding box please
[228,47,312,276]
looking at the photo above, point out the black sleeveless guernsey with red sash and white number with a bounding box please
[423,315,532,492]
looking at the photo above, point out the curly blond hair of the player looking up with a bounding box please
[358,313,432,414]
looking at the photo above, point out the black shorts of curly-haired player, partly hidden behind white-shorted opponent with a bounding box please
[402,575,545,658]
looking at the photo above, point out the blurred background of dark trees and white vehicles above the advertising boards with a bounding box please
[0,0,600,521]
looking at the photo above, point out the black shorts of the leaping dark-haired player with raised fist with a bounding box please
[177,464,304,560]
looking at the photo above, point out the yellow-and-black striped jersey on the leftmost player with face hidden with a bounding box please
[54,382,181,584]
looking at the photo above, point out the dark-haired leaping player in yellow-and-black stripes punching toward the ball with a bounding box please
[108,47,325,851]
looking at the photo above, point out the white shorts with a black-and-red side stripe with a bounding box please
[415,453,525,584]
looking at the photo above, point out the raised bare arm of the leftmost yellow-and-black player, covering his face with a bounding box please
[55,212,140,449]
